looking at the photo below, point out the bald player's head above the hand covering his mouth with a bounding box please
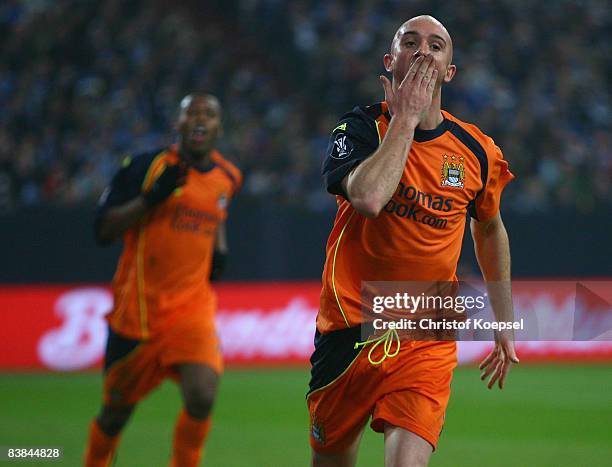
[384,17,456,92]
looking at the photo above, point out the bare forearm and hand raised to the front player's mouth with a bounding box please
[342,55,438,217]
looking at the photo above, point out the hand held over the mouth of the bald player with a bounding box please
[380,55,438,128]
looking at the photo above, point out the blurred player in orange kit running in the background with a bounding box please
[85,94,241,467]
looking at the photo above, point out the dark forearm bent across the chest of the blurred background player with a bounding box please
[97,161,187,243]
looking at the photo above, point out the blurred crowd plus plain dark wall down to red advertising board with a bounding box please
[0,0,612,282]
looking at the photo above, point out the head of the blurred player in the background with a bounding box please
[177,95,221,155]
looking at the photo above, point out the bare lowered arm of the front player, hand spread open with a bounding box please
[470,213,519,389]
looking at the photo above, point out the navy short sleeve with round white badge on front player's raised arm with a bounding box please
[322,111,379,198]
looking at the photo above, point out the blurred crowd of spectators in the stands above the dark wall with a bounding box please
[0,0,612,213]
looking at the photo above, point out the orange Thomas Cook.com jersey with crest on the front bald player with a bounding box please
[317,102,514,333]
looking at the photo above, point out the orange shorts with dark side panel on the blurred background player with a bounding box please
[104,319,223,406]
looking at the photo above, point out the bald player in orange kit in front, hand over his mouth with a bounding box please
[307,16,518,467]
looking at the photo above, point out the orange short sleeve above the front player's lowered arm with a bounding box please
[471,144,514,222]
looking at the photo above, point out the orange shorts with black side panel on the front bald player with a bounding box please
[307,328,457,453]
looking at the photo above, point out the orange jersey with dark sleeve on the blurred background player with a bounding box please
[102,147,241,339]
